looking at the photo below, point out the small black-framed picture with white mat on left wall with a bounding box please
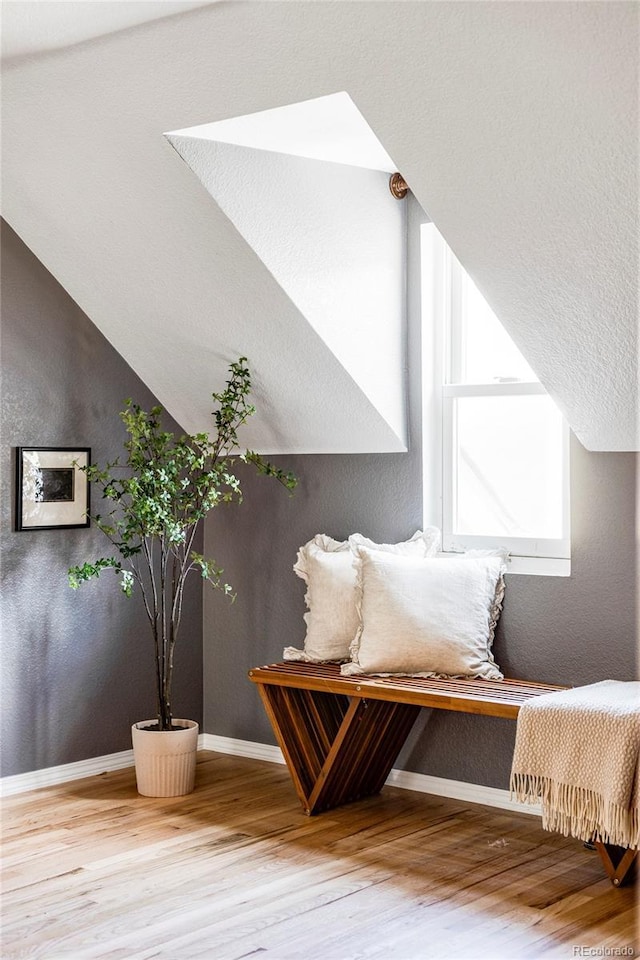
[16,447,91,530]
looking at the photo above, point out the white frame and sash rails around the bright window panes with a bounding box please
[421,219,571,576]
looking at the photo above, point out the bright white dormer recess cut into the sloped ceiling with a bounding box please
[167,93,407,451]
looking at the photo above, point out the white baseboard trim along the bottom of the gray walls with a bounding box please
[0,733,541,816]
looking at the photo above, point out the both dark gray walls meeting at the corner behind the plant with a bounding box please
[1,226,636,787]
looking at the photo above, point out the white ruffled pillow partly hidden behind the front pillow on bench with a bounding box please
[283,527,440,663]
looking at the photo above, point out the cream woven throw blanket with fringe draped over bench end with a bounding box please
[511,680,640,850]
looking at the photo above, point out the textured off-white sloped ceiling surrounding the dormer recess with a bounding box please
[2,0,638,452]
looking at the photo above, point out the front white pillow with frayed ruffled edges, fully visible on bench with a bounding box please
[341,547,506,680]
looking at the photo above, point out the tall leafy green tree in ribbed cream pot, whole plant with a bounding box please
[68,357,296,797]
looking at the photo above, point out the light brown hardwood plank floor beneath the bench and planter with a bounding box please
[1,752,639,960]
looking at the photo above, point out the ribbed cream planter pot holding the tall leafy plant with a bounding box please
[131,720,198,797]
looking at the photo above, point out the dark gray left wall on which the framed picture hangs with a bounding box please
[0,223,202,776]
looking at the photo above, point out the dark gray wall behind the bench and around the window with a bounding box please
[204,199,636,789]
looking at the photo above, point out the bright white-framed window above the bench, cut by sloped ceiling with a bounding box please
[421,224,570,575]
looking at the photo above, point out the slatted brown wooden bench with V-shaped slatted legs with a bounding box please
[249,662,637,886]
